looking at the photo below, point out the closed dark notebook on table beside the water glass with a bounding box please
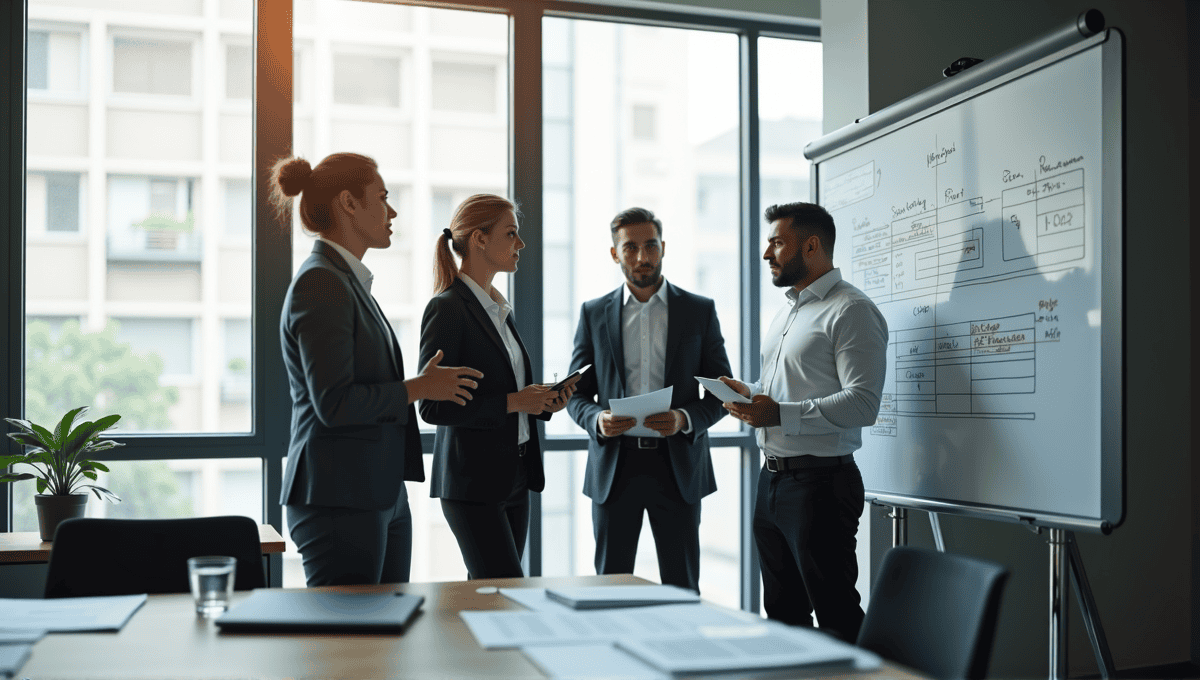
[215,589,425,633]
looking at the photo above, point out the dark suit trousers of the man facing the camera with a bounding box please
[592,447,700,592]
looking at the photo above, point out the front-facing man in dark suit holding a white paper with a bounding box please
[566,207,730,592]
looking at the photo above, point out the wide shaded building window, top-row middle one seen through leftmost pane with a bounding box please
[113,36,192,95]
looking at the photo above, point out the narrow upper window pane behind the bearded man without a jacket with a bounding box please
[754,38,820,338]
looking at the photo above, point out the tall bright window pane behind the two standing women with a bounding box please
[283,0,508,586]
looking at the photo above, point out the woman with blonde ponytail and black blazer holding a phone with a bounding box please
[420,194,578,578]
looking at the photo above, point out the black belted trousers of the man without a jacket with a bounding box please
[754,463,864,643]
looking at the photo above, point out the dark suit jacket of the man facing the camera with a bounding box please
[566,282,732,503]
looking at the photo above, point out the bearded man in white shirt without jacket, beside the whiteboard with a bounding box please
[722,203,888,642]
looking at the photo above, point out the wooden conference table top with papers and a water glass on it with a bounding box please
[17,576,925,680]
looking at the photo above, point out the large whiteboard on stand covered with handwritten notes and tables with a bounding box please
[810,31,1123,531]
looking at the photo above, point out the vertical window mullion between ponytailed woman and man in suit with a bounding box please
[509,2,545,576]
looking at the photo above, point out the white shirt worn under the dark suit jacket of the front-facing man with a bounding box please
[596,278,691,434]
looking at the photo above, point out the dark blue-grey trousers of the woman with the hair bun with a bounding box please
[287,483,413,588]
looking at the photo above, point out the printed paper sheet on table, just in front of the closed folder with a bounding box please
[458,603,761,649]
